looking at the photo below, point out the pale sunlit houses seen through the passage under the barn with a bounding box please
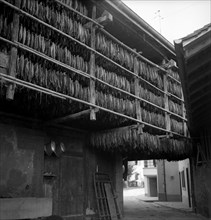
[128,159,192,203]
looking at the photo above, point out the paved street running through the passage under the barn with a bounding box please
[124,188,205,220]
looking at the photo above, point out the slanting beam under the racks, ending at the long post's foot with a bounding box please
[47,108,99,124]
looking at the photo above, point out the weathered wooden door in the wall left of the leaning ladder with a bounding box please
[60,156,84,219]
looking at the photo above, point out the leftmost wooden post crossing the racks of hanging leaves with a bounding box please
[6,0,21,100]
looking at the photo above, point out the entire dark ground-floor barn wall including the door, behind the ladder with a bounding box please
[0,121,123,220]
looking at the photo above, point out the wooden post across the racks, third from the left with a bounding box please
[134,57,143,134]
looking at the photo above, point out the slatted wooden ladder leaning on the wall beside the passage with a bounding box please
[94,172,122,220]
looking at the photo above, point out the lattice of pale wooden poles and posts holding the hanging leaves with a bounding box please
[0,0,187,137]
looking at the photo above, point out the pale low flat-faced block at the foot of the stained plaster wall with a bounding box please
[0,197,52,220]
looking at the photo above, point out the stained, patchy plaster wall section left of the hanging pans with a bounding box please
[0,124,44,198]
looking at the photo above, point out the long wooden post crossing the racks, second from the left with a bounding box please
[90,6,96,120]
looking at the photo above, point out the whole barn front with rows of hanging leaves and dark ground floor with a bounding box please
[0,0,191,220]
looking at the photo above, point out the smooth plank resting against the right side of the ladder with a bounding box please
[104,183,118,220]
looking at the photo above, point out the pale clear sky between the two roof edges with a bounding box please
[123,0,211,44]
